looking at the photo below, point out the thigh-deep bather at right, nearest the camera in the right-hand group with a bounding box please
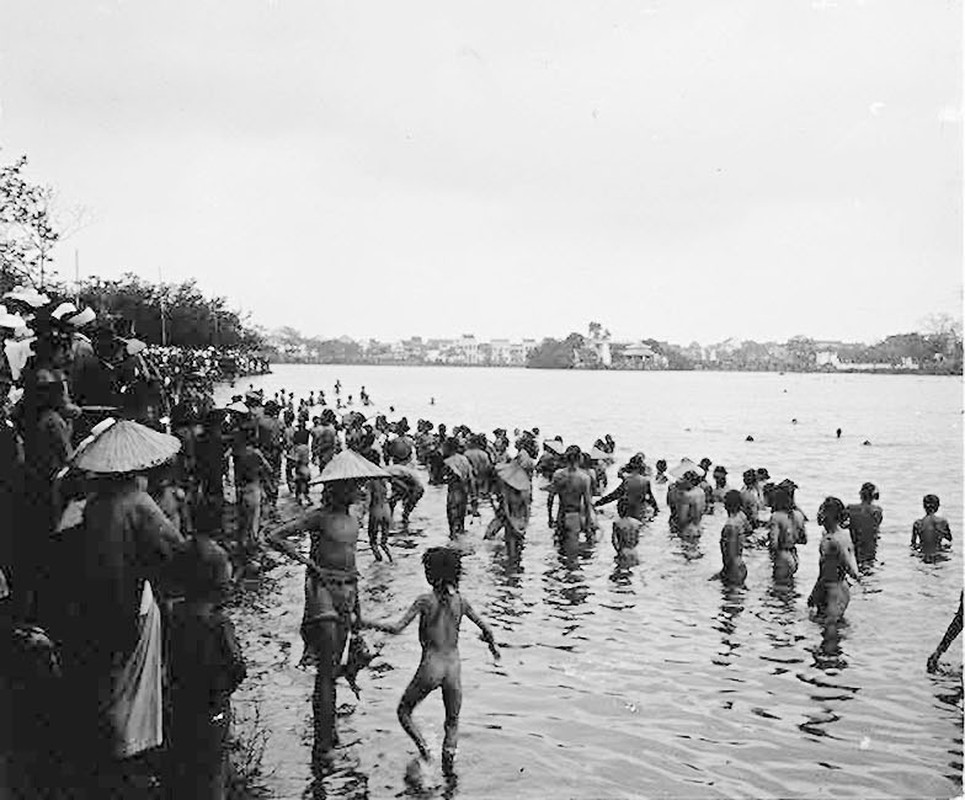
[808,497,858,622]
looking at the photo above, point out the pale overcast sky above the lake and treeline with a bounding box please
[0,0,962,343]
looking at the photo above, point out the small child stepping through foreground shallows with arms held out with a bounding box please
[363,547,499,772]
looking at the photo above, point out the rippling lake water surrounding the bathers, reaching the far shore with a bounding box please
[215,365,963,798]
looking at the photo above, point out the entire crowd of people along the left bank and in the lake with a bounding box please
[0,290,962,798]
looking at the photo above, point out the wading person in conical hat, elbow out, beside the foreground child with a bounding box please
[267,450,389,770]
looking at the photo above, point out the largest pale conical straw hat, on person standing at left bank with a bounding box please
[71,419,181,475]
